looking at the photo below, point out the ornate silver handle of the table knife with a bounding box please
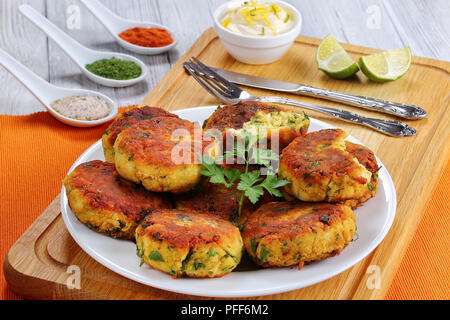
[296,85,427,119]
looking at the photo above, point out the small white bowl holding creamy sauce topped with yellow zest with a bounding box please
[214,1,302,64]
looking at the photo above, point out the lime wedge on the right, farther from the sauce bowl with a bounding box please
[359,47,411,82]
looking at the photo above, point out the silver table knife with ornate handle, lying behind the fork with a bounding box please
[210,67,427,119]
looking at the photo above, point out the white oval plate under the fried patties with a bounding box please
[61,106,397,297]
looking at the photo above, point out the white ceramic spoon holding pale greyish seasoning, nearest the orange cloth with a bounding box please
[0,49,117,127]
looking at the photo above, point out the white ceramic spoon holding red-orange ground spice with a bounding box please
[80,0,177,55]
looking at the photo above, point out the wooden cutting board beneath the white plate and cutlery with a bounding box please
[4,29,450,299]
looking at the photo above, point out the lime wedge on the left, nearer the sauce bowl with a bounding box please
[316,34,359,79]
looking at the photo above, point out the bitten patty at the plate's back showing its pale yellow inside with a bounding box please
[205,101,309,149]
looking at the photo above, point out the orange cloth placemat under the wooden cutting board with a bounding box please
[0,112,450,299]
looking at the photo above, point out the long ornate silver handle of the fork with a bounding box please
[257,97,416,136]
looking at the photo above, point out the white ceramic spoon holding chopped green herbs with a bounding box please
[19,4,147,88]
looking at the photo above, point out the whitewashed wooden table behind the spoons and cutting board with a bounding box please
[0,0,450,115]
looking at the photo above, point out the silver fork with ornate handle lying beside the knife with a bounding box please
[183,57,417,136]
